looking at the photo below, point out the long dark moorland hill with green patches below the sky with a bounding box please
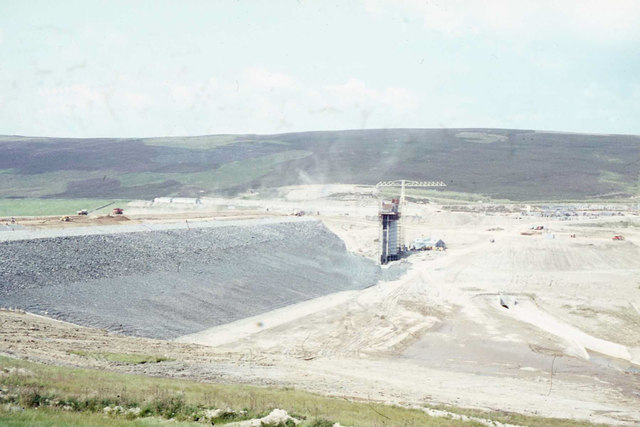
[0,129,640,200]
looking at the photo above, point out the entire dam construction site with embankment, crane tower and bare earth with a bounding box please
[0,185,640,425]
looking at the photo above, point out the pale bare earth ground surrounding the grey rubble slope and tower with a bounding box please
[0,186,640,425]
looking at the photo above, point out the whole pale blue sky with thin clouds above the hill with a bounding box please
[0,0,640,137]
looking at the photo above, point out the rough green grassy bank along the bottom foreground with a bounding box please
[0,357,604,427]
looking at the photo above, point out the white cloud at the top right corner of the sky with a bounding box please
[363,0,640,41]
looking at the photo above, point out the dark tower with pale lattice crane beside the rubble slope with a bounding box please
[376,179,447,264]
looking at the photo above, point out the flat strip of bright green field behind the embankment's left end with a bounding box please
[0,198,128,217]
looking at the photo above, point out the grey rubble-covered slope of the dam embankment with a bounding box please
[0,221,380,339]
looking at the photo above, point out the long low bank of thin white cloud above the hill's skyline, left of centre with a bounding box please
[16,67,419,136]
